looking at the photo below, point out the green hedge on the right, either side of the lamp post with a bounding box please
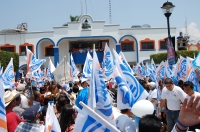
[150,50,199,64]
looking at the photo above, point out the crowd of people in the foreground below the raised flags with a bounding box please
[4,70,200,132]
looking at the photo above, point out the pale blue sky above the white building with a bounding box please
[0,0,200,40]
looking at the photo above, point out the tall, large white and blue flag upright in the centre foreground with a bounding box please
[88,51,115,126]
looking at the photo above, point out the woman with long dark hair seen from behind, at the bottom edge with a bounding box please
[59,105,77,132]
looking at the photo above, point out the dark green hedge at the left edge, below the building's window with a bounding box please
[0,50,19,72]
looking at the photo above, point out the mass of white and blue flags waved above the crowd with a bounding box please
[0,44,200,132]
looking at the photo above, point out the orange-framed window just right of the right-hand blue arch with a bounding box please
[140,38,155,50]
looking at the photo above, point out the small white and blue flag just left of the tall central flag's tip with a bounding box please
[83,52,92,78]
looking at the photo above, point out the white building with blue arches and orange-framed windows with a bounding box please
[0,15,176,69]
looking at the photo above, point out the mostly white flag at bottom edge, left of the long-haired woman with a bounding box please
[45,103,61,132]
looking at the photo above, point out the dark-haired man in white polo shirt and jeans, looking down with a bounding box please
[159,78,186,132]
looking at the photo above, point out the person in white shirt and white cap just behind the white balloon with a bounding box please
[148,82,158,115]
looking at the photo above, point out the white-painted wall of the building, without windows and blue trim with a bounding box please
[0,15,177,69]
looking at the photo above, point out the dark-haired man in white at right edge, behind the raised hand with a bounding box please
[183,81,200,131]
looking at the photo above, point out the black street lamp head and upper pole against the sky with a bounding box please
[161,1,175,38]
